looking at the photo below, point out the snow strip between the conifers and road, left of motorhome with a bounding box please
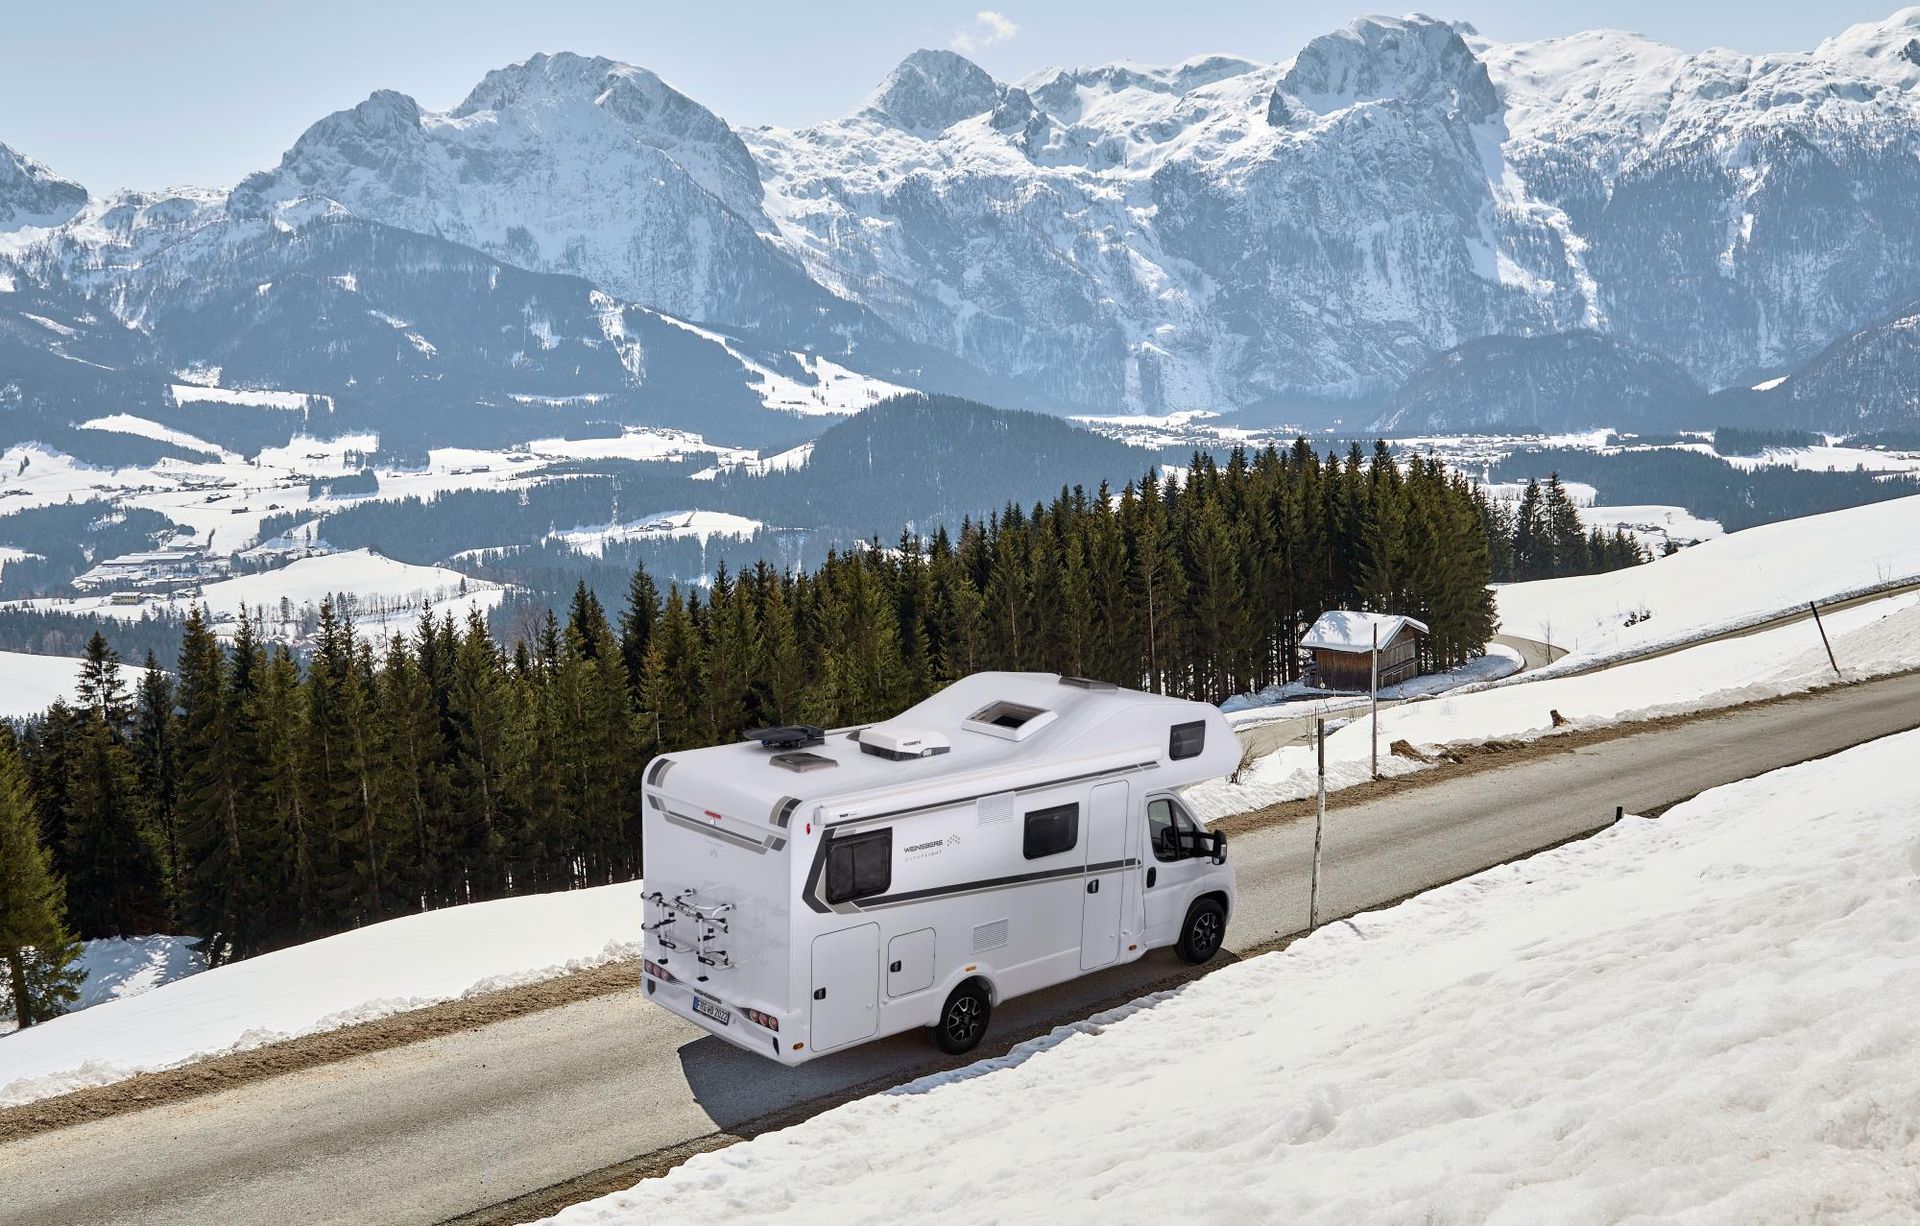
[0,881,641,1107]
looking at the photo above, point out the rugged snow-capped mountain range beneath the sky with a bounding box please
[0,8,1920,437]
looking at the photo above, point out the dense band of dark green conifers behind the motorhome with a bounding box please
[0,441,1635,1021]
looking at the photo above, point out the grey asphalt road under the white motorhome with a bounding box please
[11,675,1920,1226]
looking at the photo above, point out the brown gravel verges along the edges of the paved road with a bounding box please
[0,670,1920,1158]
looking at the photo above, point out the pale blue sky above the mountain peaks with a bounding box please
[0,0,1897,192]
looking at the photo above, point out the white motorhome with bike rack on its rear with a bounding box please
[643,673,1240,1065]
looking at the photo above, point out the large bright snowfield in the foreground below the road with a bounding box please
[555,733,1920,1226]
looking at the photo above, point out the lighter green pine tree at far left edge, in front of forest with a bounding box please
[0,733,84,1028]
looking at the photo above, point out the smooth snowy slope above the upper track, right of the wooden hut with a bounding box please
[1496,495,1920,668]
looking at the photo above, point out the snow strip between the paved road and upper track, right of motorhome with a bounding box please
[1187,590,1920,817]
